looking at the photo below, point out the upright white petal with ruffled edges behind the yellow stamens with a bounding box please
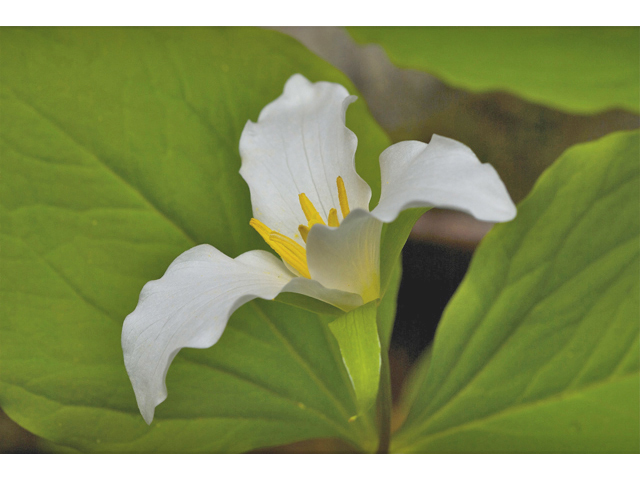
[240,74,371,245]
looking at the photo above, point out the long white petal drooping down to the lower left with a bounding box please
[122,245,293,423]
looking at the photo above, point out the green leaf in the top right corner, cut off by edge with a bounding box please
[349,27,640,114]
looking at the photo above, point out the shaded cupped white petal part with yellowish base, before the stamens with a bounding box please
[307,209,382,303]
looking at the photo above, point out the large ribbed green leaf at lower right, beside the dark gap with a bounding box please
[392,131,640,453]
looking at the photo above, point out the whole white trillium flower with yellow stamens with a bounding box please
[122,75,516,423]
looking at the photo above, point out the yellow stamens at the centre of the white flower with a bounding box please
[249,177,350,278]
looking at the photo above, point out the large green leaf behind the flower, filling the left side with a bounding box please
[0,29,397,452]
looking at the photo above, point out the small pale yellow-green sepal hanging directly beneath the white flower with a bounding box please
[329,302,381,413]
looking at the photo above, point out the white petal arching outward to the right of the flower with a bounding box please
[371,135,516,222]
